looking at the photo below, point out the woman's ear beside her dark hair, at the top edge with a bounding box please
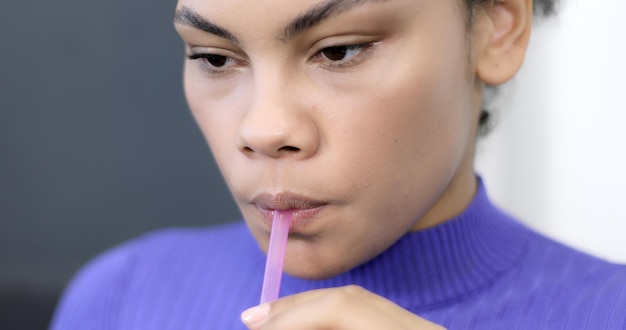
[472,0,533,85]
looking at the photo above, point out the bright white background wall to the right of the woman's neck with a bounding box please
[477,0,626,262]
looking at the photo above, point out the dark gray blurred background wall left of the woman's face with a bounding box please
[0,0,239,329]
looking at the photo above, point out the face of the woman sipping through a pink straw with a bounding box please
[175,0,481,278]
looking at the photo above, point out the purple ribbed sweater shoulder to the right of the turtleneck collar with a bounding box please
[451,230,626,329]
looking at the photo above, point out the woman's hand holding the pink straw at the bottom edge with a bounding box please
[241,286,444,330]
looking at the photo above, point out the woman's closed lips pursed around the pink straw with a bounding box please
[250,192,329,232]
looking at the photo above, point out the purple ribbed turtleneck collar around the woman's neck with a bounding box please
[283,179,529,310]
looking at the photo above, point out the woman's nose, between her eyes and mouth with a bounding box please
[238,76,320,160]
